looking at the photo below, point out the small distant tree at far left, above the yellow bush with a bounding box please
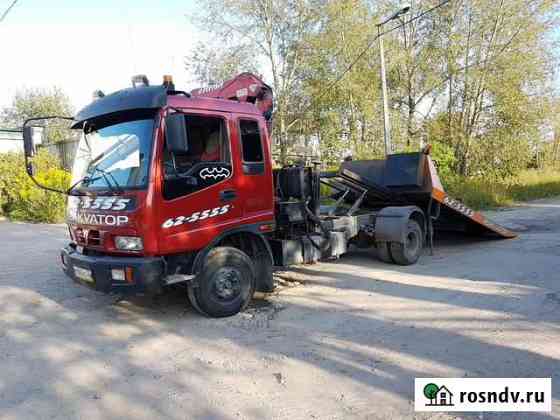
[0,87,74,143]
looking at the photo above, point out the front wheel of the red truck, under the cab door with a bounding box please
[189,246,255,318]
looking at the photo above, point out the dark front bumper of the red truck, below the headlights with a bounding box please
[60,245,165,294]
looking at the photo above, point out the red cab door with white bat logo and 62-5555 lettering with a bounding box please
[158,111,243,254]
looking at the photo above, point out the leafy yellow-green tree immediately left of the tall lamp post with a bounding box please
[299,0,382,164]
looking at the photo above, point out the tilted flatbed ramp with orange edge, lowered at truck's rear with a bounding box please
[321,152,517,239]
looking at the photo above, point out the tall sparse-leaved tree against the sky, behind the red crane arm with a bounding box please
[187,0,321,162]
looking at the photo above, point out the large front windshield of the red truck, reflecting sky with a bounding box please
[72,119,154,189]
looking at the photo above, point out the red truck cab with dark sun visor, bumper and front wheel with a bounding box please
[24,76,275,316]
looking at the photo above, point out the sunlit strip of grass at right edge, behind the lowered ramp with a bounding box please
[444,170,560,210]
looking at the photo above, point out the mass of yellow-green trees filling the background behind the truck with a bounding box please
[187,0,560,171]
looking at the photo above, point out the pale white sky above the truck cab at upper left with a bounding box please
[0,0,199,110]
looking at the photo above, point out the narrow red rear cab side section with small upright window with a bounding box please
[237,116,274,223]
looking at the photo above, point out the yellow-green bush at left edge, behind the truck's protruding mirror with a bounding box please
[0,150,70,223]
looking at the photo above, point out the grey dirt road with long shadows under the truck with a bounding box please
[0,199,560,420]
